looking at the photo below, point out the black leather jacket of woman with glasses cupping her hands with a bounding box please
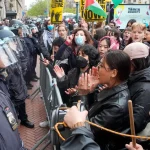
[89,83,130,150]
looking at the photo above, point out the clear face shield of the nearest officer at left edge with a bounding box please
[0,43,17,68]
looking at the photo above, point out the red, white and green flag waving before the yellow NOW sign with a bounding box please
[85,0,107,18]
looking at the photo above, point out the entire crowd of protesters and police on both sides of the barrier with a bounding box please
[0,16,150,150]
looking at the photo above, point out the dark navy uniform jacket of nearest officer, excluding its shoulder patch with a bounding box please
[0,90,25,150]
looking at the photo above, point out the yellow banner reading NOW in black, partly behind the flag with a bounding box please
[80,0,106,22]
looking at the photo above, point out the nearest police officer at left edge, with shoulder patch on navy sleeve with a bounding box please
[0,41,25,150]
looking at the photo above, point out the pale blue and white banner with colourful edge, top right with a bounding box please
[114,4,150,29]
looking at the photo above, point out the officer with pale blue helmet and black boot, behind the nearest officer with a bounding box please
[0,30,34,128]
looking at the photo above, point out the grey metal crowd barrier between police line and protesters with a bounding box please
[30,54,63,150]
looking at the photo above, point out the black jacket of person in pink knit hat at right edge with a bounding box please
[128,67,150,133]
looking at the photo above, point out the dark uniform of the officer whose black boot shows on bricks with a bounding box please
[7,64,28,121]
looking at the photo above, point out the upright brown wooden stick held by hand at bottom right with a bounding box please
[128,100,136,148]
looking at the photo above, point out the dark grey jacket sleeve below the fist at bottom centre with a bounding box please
[60,127,100,150]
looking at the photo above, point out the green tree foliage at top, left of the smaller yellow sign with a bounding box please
[27,0,47,16]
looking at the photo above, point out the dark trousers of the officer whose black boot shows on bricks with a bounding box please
[15,102,28,122]
